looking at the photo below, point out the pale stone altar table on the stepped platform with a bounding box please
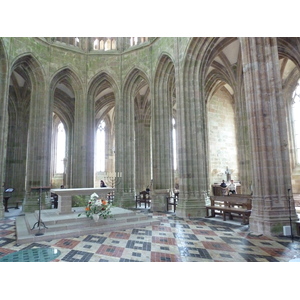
[51,187,115,214]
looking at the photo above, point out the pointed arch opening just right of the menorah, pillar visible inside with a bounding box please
[120,68,151,197]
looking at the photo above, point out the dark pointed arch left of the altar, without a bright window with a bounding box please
[7,53,50,211]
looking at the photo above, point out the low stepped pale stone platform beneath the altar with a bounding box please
[16,207,160,244]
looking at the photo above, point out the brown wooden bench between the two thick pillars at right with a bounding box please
[206,194,252,225]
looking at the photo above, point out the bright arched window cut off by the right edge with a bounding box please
[292,79,300,165]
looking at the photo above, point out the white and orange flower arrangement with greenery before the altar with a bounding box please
[78,193,112,219]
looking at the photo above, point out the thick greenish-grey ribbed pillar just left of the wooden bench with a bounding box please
[176,39,210,218]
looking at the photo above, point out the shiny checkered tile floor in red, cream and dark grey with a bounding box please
[0,210,300,262]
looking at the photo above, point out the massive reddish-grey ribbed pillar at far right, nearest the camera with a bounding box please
[240,37,298,235]
